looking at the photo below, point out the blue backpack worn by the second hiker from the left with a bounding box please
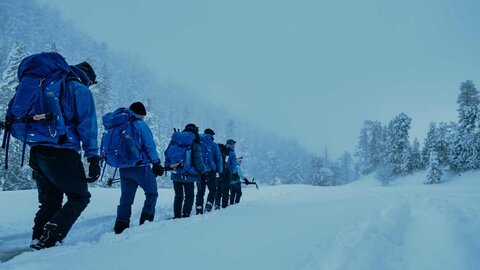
[101,108,143,168]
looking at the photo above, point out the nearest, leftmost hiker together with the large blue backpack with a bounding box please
[3,53,100,250]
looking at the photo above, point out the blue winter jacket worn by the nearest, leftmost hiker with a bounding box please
[33,75,98,158]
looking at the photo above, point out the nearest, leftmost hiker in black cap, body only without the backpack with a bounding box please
[29,62,100,250]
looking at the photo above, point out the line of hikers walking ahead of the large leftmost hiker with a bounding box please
[105,102,255,234]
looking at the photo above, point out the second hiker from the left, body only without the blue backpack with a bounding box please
[114,102,163,234]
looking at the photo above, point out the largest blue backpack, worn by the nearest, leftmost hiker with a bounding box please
[2,53,72,168]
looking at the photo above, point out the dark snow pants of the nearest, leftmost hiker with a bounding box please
[29,145,90,239]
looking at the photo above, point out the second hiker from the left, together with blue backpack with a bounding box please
[102,102,163,234]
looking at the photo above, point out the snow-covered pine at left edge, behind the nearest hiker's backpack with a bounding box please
[0,42,35,190]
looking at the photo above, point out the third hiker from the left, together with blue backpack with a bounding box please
[165,124,207,218]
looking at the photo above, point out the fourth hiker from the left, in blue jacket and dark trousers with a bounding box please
[195,128,223,215]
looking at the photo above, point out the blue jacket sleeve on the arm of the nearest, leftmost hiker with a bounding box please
[75,85,98,158]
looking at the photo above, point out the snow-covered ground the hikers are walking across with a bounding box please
[0,172,480,270]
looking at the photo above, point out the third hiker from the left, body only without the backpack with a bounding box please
[171,124,207,218]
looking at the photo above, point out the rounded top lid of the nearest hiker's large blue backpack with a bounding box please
[17,52,71,81]
